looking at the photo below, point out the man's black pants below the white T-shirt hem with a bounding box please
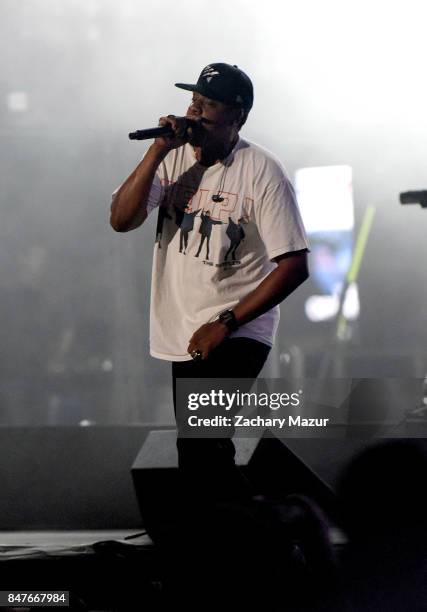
[172,338,270,499]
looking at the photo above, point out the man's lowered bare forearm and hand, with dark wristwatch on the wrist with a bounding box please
[188,249,309,358]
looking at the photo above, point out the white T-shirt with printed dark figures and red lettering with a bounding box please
[117,138,308,361]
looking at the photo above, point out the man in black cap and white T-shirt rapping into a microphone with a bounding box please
[110,63,308,498]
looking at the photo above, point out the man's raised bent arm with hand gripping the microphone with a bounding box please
[110,115,186,232]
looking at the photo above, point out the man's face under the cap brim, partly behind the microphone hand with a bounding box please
[186,92,240,146]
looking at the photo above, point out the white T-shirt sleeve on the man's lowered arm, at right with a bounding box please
[254,178,309,259]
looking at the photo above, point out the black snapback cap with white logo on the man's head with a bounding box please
[175,63,254,110]
